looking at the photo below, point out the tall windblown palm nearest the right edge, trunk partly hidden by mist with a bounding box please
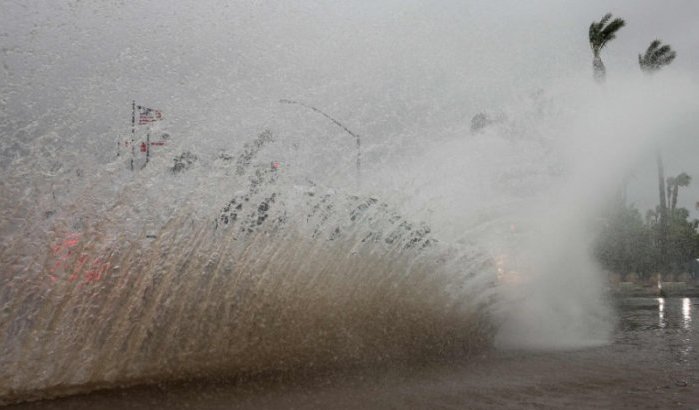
[640,40,677,272]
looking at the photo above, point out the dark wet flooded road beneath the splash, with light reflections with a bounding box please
[7,298,699,410]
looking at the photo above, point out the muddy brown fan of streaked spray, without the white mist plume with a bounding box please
[0,132,492,397]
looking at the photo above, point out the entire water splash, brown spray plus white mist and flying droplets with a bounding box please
[0,1,697,404]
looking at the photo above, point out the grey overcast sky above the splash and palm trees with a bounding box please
[0,0,699,216]
